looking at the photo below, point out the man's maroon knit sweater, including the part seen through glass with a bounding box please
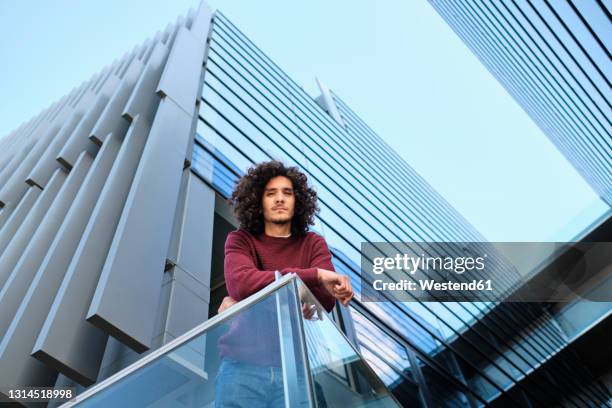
[219,229,335,366]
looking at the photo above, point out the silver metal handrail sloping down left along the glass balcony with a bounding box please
[60,273,297,408]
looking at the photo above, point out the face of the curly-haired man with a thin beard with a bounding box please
[261,176,295,224]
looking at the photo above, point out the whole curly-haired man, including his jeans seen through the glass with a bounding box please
[215,161,353,408]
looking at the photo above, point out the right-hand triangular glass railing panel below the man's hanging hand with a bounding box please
[297,281,399,407]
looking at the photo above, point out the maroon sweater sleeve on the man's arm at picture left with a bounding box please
[223,233,320,301]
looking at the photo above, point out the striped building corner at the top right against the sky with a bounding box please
[430,0,612,205]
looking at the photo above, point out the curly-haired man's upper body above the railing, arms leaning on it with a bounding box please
[219,161,353,312]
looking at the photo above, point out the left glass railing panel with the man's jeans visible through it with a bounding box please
[77,284,309,408]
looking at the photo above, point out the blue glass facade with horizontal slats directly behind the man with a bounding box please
[192,12,609,407]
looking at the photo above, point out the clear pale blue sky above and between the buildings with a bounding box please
[0,0,609,241]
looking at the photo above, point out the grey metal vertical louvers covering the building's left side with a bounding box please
[0,3,212,396]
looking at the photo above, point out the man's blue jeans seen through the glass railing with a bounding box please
[215,357,308,408]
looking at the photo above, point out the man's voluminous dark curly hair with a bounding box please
[228,160,319,236]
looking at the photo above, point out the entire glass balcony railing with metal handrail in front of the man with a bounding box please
[62,274,400,408]
